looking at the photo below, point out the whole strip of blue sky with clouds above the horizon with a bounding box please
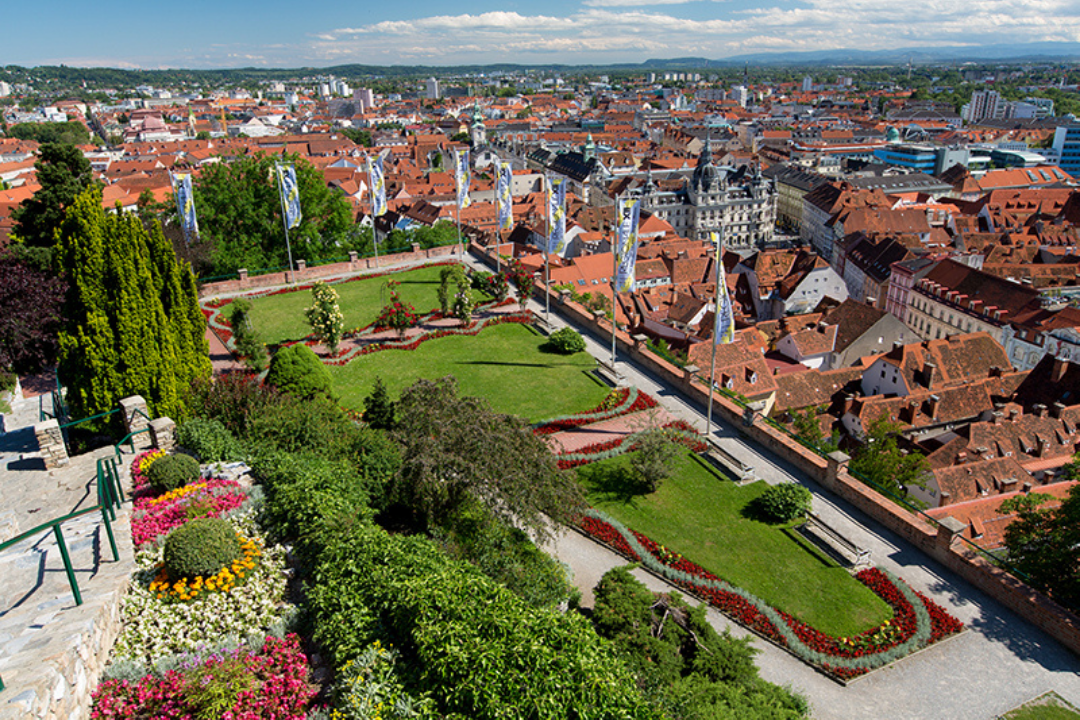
[6,0,1080,69]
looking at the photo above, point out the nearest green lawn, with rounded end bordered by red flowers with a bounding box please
[578,452,892,637]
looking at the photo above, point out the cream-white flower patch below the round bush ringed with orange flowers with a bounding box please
[112,512,293,660]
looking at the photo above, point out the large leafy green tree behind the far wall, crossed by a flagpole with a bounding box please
[194,154,359,275]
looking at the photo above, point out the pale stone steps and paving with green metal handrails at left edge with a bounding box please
[0,388,135,720]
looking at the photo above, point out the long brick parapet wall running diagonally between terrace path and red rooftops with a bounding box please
[470,244,1080,654]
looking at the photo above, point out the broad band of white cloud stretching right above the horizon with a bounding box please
[172,0,1080,65]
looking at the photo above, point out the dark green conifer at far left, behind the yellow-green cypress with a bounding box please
[12,142,96,247]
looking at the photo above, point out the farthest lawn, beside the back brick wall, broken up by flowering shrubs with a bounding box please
[252,266,445,345]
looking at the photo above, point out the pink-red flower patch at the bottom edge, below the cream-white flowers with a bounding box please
[91,635,315,720]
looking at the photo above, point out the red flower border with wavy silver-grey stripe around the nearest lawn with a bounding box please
[580,510,963,679]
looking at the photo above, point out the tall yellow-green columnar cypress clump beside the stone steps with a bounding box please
[57,189,211,419]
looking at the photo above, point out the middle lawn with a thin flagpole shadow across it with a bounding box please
[330,324,610,422]
